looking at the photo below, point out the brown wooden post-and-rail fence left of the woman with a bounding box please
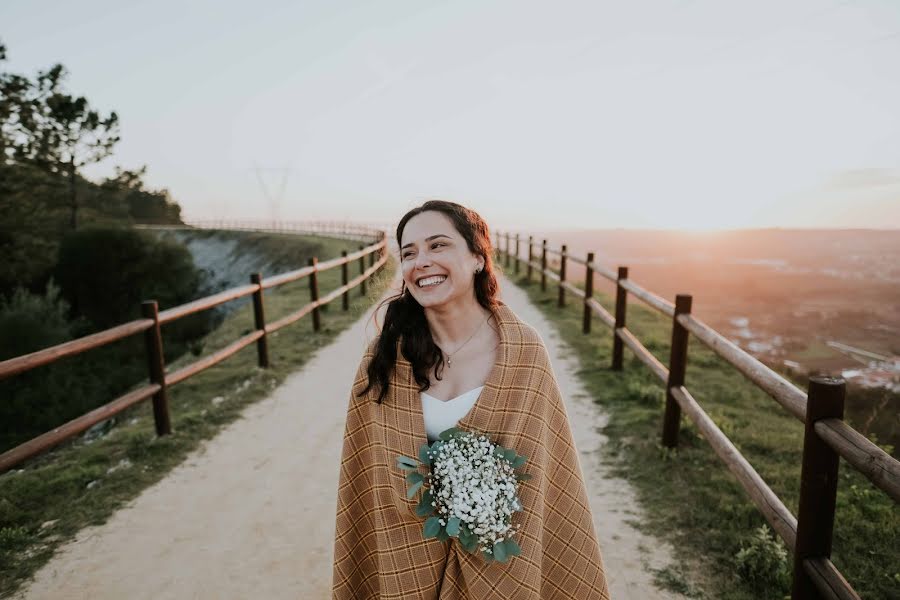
[0,222,387,473]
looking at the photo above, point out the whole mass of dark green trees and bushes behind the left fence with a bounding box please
[0,43,203,450]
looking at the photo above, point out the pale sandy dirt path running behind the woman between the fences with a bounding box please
[18,274,675,600]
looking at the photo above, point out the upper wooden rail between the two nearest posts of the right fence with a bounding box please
[678,315,806,422]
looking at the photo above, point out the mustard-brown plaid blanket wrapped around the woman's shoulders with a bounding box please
[333,301,609,600]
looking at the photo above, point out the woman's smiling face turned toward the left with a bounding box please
[400,210,484,308]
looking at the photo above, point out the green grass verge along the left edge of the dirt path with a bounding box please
[0,236,396,597]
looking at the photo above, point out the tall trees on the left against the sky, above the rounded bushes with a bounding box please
[0,38,181,297]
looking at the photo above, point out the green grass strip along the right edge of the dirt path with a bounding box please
[506,267,900,600]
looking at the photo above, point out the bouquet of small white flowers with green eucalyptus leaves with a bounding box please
[397,427,530,563]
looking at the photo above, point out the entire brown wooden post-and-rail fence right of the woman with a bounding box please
[495,233,900,600]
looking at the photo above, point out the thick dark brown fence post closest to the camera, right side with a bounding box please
[791,375,847,600]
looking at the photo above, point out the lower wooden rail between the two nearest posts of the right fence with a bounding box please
[670,386,797,552]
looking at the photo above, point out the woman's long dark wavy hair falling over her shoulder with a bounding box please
[358,200,500,404]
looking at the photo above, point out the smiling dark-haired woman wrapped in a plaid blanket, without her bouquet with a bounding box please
[333,200,609,600]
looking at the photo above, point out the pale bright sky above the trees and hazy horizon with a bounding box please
[0,0,900,229]
